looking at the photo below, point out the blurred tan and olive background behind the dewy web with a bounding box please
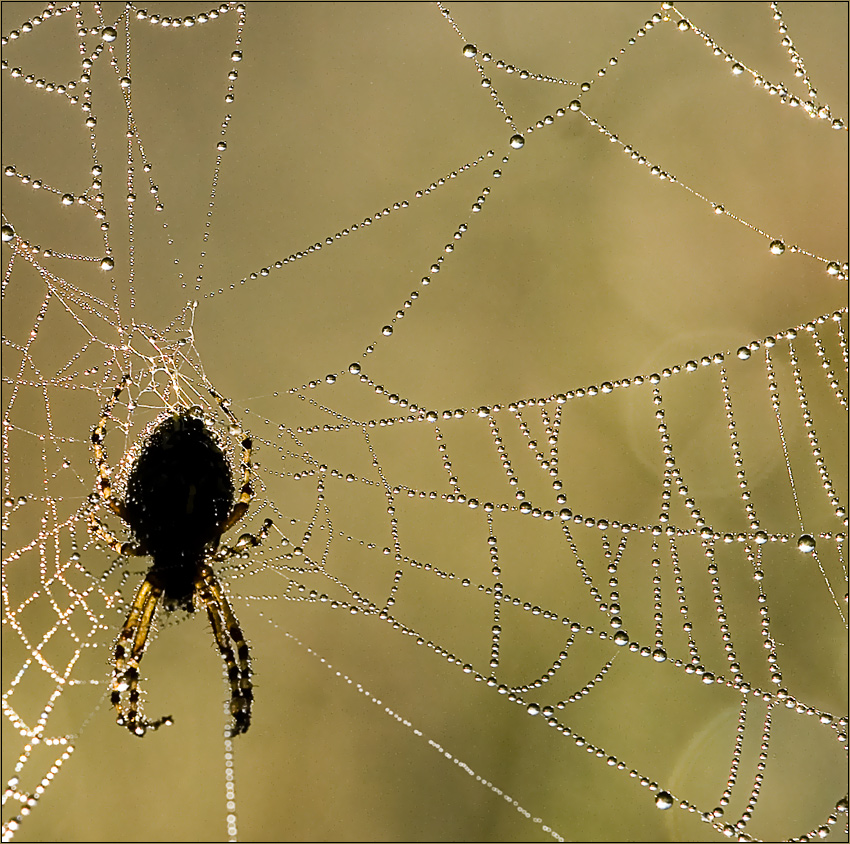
[2,3,847,841]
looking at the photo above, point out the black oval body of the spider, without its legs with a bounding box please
[125,410,234,609]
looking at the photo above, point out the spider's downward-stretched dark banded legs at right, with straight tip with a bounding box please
[195,566,254,736]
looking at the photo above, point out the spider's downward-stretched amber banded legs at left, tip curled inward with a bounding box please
[112,576,172,737]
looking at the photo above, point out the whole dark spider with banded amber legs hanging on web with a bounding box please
[89,377,272,736]
